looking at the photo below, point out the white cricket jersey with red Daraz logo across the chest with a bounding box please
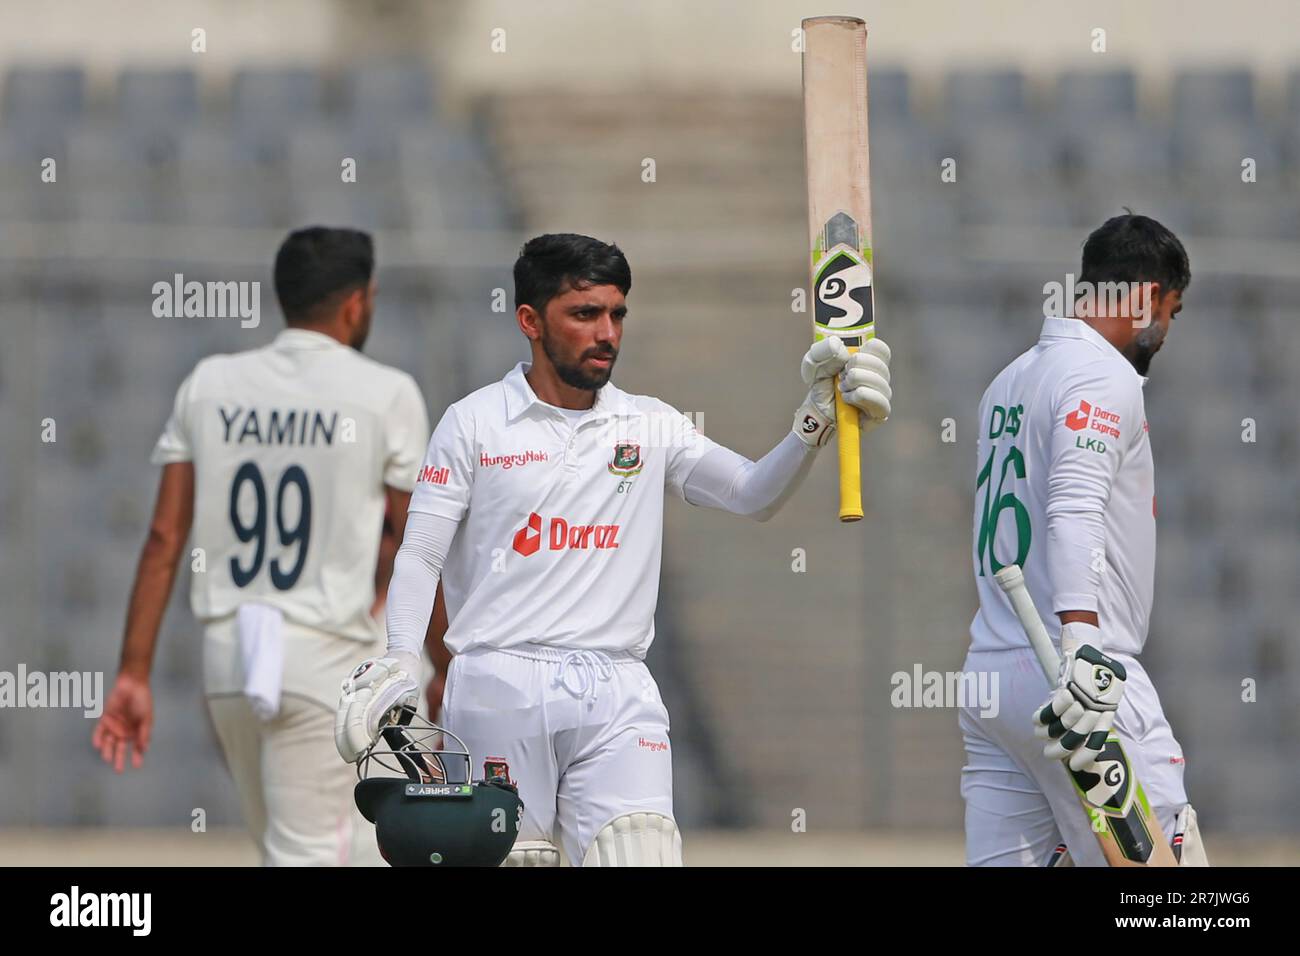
[411,363,716,657]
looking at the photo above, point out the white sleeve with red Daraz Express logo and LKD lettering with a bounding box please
[1045,362,1143,613]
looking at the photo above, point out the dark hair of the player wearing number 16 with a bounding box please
[1079,207,1192,291]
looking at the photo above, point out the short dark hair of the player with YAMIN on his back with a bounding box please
[276,226,374,323]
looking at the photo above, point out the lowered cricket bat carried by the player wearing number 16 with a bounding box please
[993,564,1178,866]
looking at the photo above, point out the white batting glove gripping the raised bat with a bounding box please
[793,336,893,447]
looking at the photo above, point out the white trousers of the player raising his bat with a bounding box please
[442,644,672,866]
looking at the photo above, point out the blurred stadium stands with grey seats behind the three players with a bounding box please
[0,0,1300,864]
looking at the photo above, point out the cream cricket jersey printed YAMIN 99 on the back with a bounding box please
[152,329,429,641]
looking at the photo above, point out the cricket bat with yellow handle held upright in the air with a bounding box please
[803,17,875,522]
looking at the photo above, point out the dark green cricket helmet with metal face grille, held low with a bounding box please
[354,705,524,866]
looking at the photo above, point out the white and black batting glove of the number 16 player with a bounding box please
[1034,622,1127,770]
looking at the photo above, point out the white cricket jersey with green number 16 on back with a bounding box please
[971,319,1156,654]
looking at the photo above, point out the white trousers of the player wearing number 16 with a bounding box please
[959,648,1187,866]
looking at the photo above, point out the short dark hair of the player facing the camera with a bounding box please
[515,233,632,315]
